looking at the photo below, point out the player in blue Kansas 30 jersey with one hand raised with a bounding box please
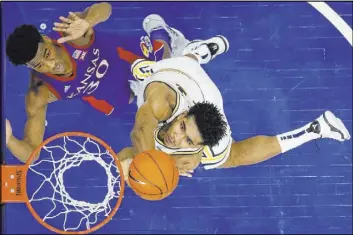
[6,3,213,162]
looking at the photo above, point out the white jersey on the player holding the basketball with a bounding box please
[132,57,232,169]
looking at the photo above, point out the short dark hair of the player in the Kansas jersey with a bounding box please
[6,24,43,66]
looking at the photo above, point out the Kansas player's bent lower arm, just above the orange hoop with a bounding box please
[6,78,53,162]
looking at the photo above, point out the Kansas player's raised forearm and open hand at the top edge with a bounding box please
[53,2,112,43]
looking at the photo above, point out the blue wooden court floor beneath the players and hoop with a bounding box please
[2,2,352,234]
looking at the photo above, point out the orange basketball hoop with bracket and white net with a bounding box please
[0,132,124,234]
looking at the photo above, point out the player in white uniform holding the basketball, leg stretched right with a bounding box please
[119,14,350,177]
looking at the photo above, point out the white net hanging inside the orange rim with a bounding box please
[27,136,121,231]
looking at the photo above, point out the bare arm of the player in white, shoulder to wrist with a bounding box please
[130,82,172,154]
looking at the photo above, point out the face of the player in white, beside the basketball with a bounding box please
[163,113,203,148]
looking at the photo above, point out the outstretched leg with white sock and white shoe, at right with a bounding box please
[220,111,351,168]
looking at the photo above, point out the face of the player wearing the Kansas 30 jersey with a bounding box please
[27,40,67,74]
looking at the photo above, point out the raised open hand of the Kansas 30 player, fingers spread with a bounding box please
[53,12,91,43]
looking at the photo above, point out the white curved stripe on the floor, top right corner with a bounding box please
[308,2,353,46]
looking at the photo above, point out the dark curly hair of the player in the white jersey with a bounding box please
[187,102,227,147]
